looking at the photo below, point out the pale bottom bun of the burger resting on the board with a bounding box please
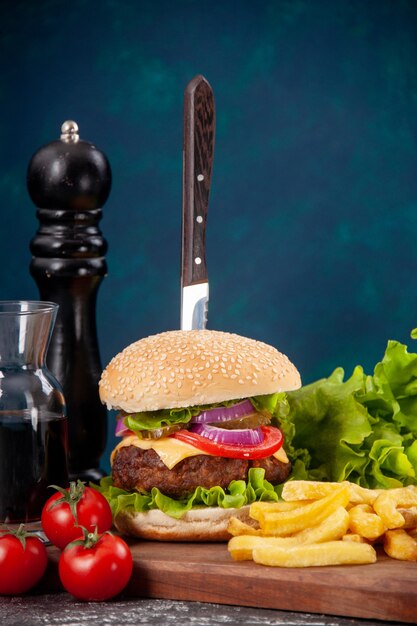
[114,505,254,541]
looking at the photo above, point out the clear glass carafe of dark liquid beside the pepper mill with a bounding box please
[0,301,68,523]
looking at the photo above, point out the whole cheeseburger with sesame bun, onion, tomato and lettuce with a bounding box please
[99,330,301,541]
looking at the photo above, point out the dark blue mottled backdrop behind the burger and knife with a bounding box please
[0,0,417,466]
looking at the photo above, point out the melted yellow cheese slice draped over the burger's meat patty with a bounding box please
[110,435,288,469]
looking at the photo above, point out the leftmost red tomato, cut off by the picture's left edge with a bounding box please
[0,526,48,595]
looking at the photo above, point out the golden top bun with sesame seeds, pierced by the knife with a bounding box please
[99,330,301,413]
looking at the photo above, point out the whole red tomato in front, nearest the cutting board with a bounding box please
[59,533,133,601]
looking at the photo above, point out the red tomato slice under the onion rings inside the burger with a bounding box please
[170,426,284,459]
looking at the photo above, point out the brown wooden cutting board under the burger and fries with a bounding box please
[42,541,417,623]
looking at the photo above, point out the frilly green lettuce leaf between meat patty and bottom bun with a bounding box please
[94,468,279,519]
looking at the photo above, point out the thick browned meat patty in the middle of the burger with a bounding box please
[112,446,291,498]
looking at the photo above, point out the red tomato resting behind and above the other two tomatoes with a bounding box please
[41,480,112,550]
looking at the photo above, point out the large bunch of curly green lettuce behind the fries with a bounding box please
[276,329,417,488]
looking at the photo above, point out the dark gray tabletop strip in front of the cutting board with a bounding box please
[0,593,406,626]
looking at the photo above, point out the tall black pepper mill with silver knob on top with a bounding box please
[27,121,111,481]
